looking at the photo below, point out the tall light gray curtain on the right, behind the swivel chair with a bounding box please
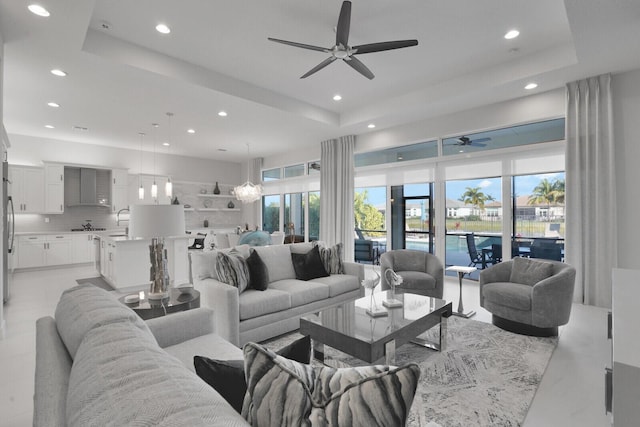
[565,75,618,307]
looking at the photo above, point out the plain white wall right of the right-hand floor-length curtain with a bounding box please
[611,70,640,269]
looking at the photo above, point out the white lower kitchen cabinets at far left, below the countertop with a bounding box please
[17,234,73,268]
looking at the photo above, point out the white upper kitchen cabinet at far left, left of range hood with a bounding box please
[9,165,45,214]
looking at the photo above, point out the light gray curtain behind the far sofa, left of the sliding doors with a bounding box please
[320,135,355,261]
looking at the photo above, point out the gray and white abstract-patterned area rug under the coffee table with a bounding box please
[263,317,558,427]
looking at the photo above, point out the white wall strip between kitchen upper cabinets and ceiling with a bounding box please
[9,135,241,184]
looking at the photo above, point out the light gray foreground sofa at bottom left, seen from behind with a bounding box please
[33,284,249,427]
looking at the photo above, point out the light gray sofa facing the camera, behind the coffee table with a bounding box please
[190,243,364,346]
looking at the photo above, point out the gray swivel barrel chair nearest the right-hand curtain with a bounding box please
[480,257,576,336]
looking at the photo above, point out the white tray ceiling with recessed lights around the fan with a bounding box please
[0,0,640,161]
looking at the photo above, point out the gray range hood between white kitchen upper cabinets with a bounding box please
[65,168,110,207]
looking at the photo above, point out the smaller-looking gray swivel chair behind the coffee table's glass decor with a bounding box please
[380,249,444,298]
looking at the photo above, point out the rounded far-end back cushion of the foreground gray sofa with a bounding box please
[55,283,155,359]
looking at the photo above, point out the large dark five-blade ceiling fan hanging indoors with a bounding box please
[268,1,418,80]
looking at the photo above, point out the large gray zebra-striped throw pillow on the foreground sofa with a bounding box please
[242,343,420,427]
